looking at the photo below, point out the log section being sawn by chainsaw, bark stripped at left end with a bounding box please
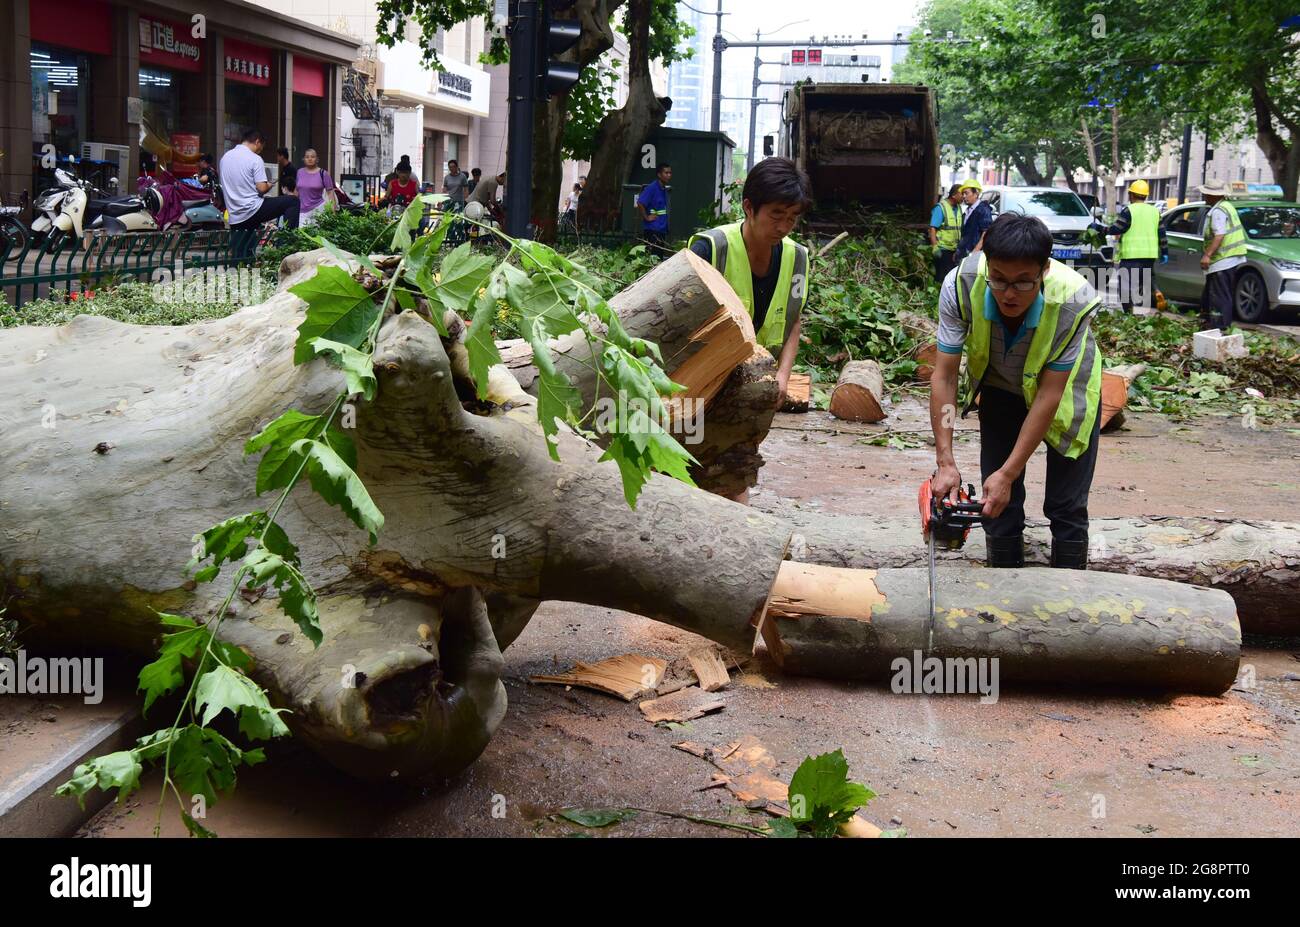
[762,563,1242,694]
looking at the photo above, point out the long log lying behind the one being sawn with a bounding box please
[783,511,1300,636]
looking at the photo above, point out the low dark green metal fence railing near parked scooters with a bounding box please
[0,229,273,307]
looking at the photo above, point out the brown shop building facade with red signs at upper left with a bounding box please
[0,0,360,194]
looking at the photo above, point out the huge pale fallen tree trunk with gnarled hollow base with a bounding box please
[0,251,1248,779]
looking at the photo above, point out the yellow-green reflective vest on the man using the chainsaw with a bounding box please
[957,252,1102,458]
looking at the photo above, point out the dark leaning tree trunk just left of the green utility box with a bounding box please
[577,0,668,230]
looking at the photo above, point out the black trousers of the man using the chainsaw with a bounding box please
[979,385,1101,541]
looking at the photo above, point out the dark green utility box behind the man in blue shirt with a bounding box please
[623,127,736,241]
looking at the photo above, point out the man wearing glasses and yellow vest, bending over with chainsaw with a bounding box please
[930,212,1101,569]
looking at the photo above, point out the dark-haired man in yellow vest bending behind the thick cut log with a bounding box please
[690,157,813,402]
